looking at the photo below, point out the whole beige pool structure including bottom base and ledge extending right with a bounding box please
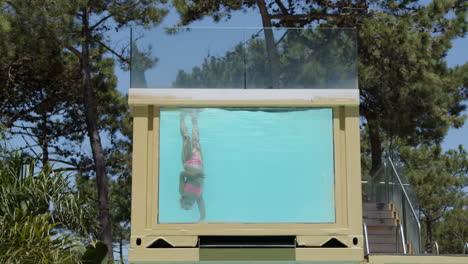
[129,89,468,264]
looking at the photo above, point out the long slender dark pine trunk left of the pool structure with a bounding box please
[81,8,114,263]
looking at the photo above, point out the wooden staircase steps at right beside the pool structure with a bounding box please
[363,203,403,253]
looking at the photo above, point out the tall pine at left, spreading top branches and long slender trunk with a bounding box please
[2,0,167,261]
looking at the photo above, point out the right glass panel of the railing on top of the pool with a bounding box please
[246,28,358,89]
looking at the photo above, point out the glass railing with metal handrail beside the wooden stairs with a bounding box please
[362,159,421,254]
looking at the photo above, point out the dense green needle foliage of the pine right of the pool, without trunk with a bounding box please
[359,11,464,145]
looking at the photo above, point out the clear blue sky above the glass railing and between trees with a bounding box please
[111,7,468,153]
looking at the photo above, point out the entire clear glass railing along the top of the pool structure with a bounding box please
[131,28,358,89]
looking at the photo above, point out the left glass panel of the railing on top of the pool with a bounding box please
[130,28,245,88]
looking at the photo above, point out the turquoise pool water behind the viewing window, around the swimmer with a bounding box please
[158,108,335,223]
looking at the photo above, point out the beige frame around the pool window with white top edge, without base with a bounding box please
[129,89,363,260]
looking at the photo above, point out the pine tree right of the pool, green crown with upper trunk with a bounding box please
[359,0,468,174]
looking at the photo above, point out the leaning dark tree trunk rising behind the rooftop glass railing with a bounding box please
[257,0,280,88]
